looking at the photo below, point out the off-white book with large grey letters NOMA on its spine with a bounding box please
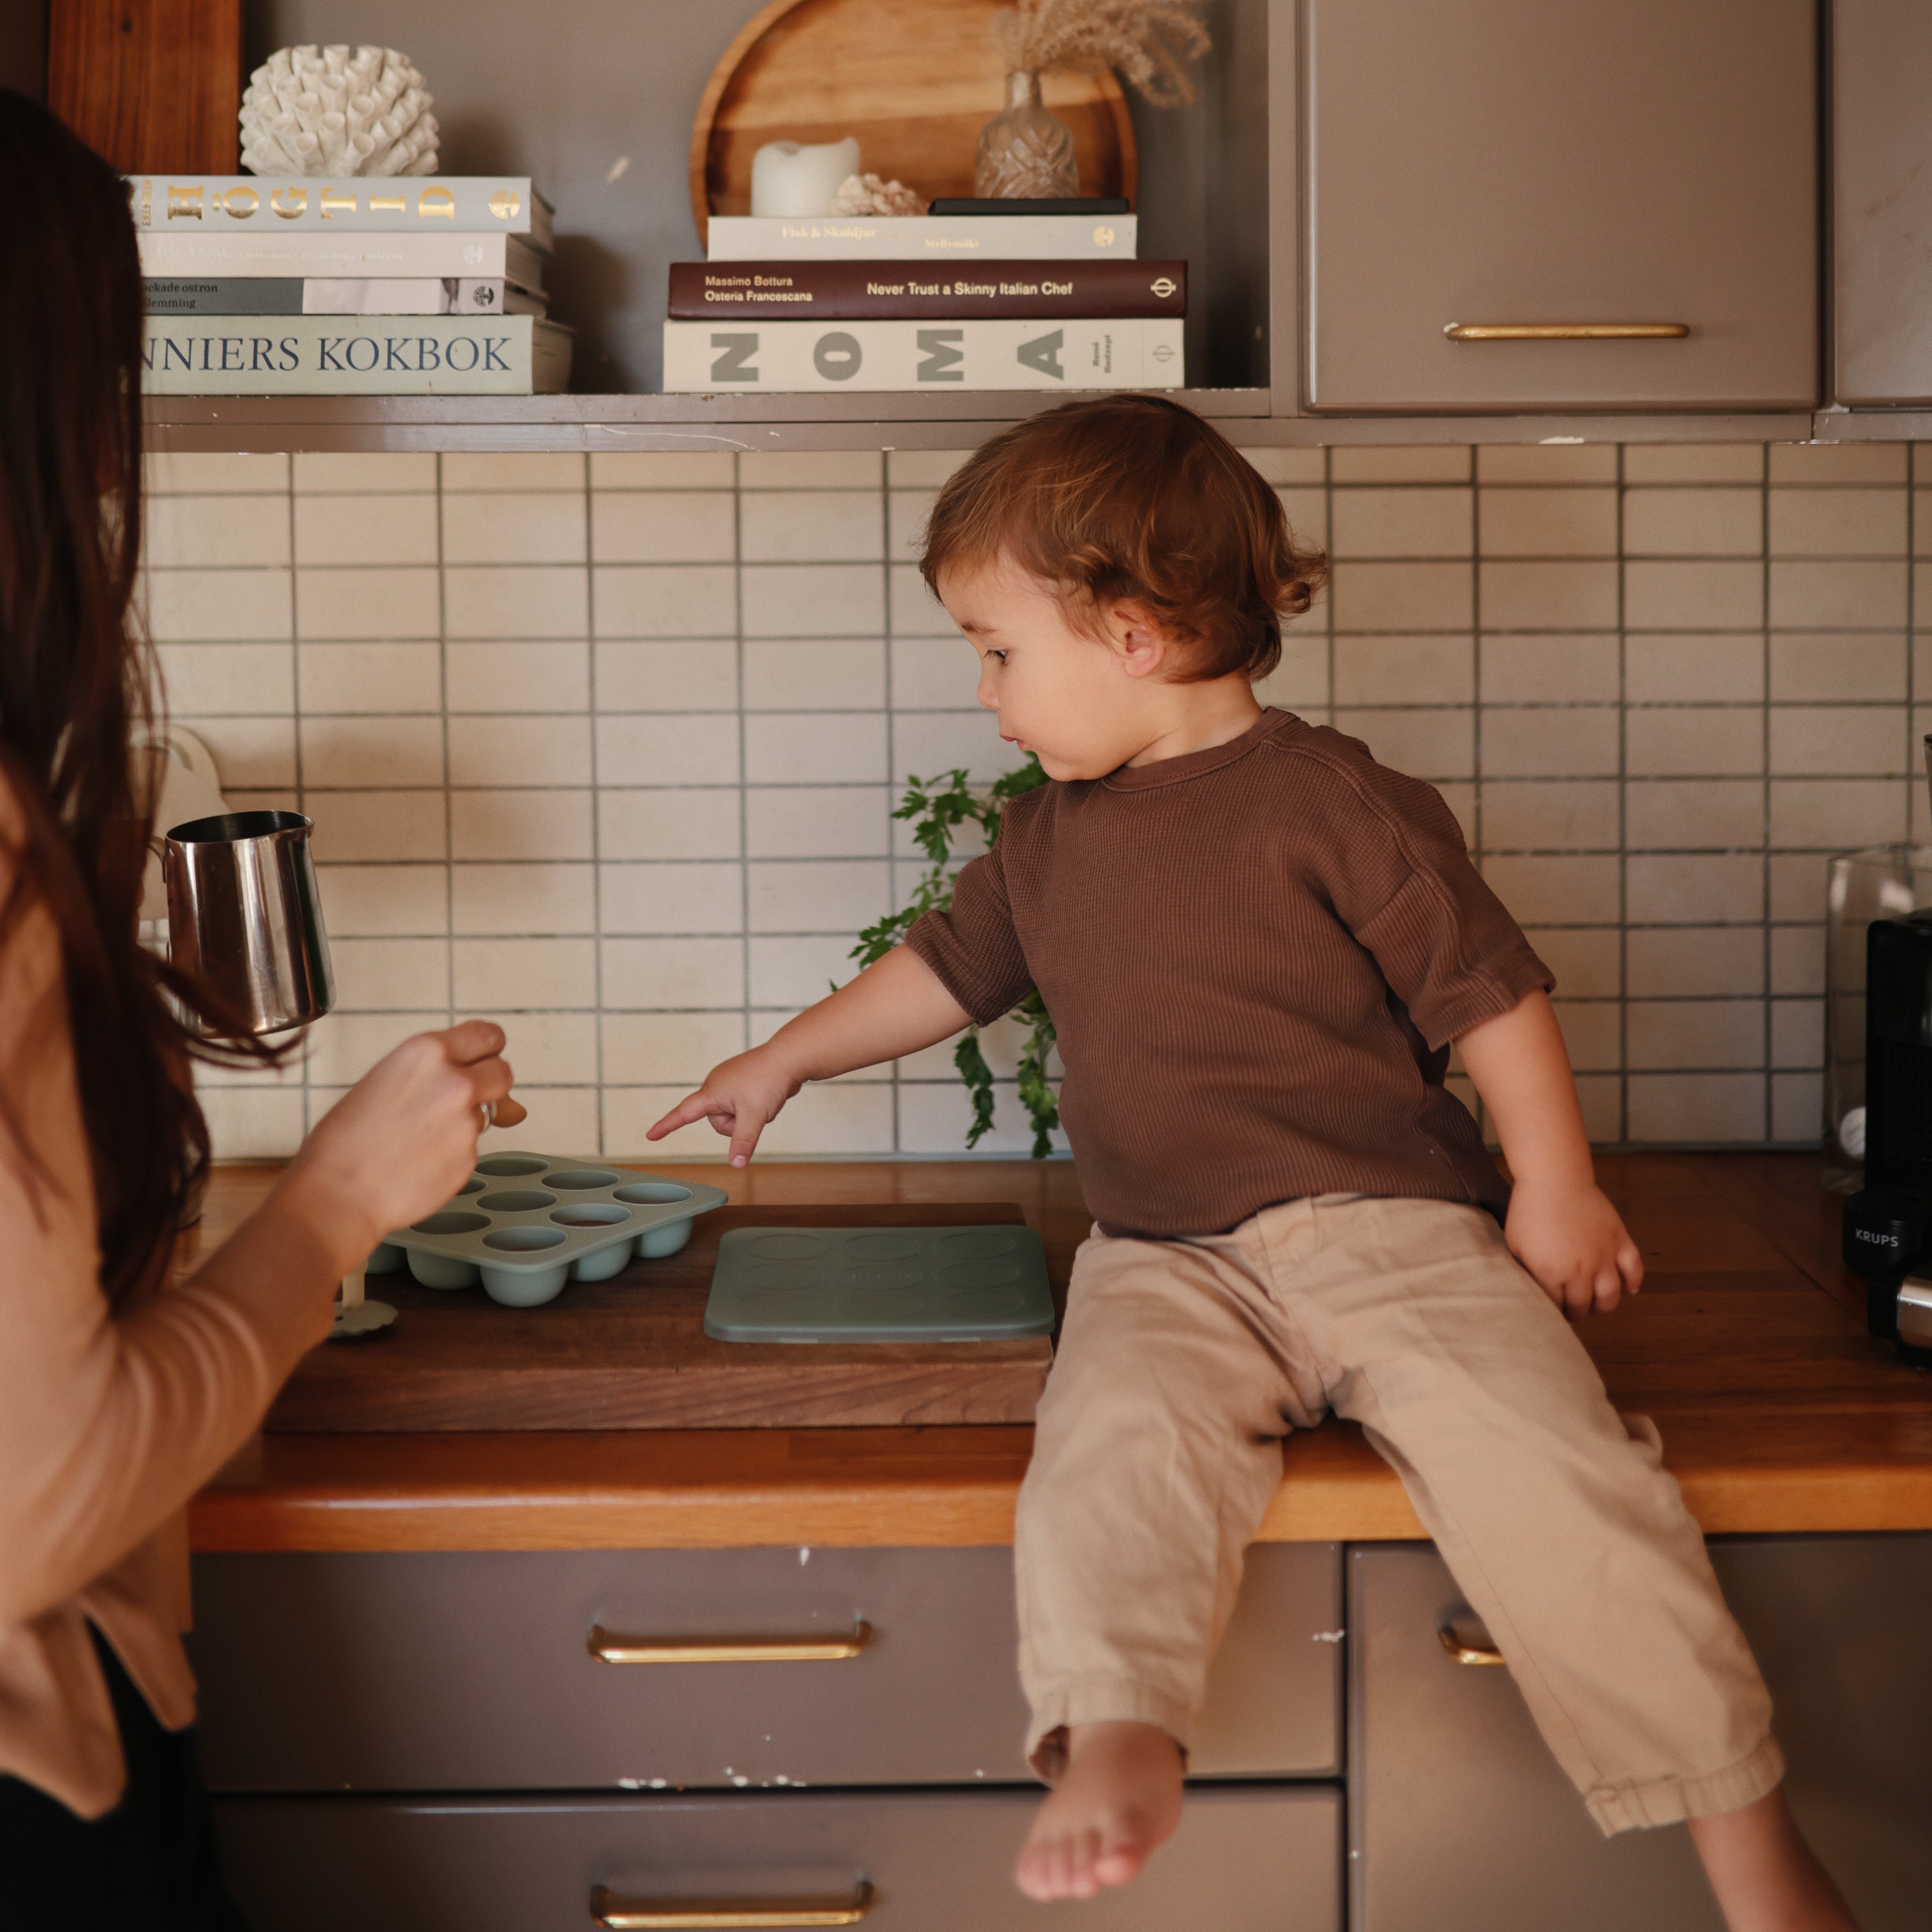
[665,315,1184,396]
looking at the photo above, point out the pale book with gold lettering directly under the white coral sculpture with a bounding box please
[122,174,554,255]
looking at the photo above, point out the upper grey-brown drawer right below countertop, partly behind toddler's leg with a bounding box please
[191,1544,1341,1791]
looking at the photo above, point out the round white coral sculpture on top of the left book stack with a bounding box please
[242,46,439,176]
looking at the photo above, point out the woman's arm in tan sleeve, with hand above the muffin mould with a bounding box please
[0,867,514,1627]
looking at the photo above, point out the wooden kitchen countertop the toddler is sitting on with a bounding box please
[185,1153,1932,1549]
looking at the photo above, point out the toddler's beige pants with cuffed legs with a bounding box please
[1014,1196,1783,1832]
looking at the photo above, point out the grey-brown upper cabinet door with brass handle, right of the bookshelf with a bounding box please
[1302,0,1816,413]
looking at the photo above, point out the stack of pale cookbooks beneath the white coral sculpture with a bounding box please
[128,174,572,396]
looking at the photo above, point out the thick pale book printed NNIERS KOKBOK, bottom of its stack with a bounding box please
[141,315,572,396]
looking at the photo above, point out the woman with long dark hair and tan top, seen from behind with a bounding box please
[0,91,522,1932]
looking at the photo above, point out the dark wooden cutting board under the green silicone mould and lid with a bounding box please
[265,1202,1053,1434]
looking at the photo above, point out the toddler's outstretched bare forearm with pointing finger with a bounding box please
[645,947,972,1167]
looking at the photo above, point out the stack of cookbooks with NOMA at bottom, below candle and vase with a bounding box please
[665,201,1188,394]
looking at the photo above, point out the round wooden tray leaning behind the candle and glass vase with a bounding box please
[692,0,1138,238]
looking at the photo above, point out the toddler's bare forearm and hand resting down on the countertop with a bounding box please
[1457,993,1644,1316]
